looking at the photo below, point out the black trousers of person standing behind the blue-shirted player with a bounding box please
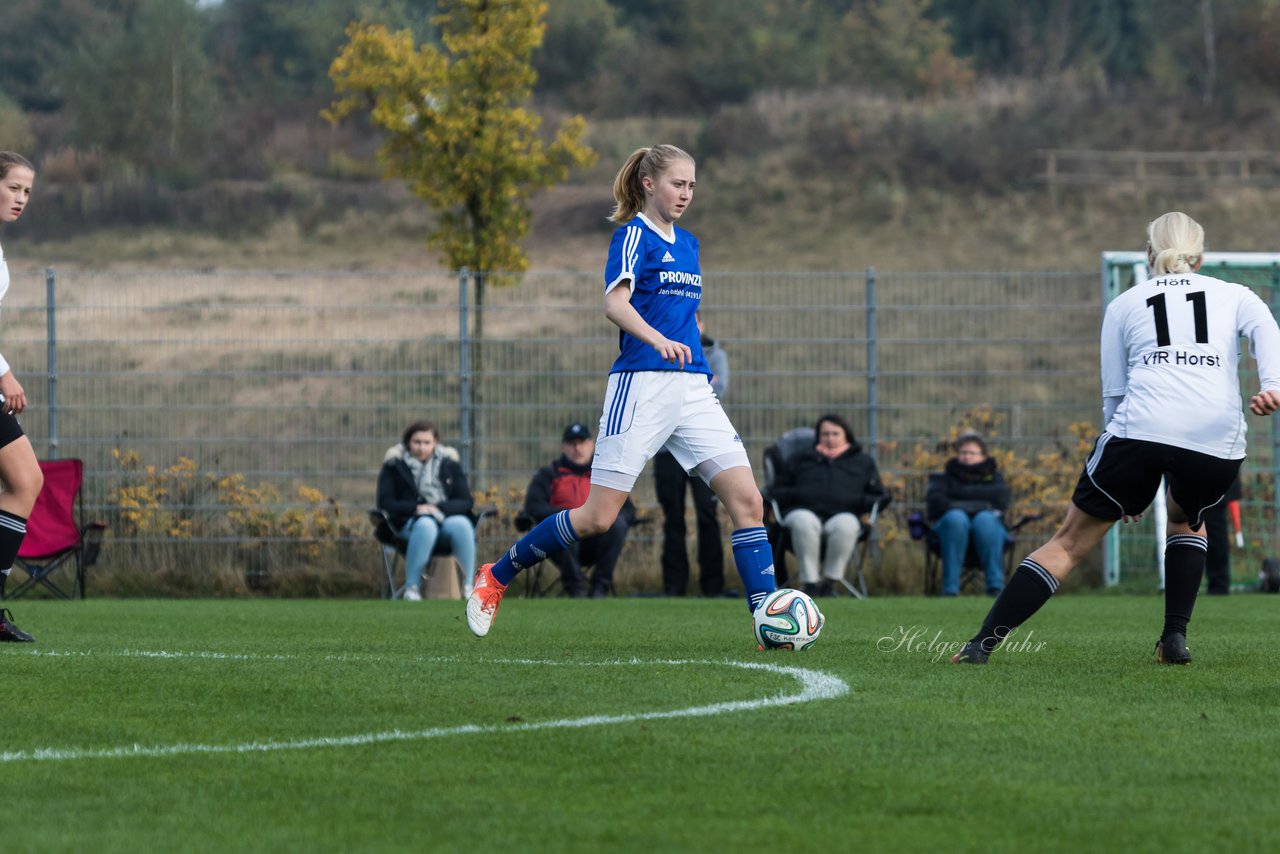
[653,451,724,597]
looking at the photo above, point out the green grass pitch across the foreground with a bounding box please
[0,594,1280,851]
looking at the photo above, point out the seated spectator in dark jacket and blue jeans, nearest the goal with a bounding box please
[924,431,1010,597]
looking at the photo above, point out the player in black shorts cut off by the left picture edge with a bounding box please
[0,151,45,643]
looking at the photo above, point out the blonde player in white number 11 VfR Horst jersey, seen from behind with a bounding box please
[951,211,1280,665]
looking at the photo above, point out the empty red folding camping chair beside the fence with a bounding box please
[8,460,106,599]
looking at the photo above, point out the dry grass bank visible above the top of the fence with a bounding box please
[17,174,1280,271]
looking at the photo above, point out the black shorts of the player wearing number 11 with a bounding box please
[1071,433,1244,530]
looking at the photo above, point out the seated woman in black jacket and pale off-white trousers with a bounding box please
[769,415,884,595]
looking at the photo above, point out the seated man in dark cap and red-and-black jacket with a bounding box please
[524,421,635,597]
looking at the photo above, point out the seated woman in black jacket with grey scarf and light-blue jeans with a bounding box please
[378,421,476,602]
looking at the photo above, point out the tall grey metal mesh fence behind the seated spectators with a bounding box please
[3,270,1269,594]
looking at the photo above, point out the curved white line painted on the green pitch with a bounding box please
[0,652,849,763]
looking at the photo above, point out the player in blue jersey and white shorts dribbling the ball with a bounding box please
[467,145,773,638]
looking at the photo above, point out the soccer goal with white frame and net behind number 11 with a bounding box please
[1101,251,1280,589]
